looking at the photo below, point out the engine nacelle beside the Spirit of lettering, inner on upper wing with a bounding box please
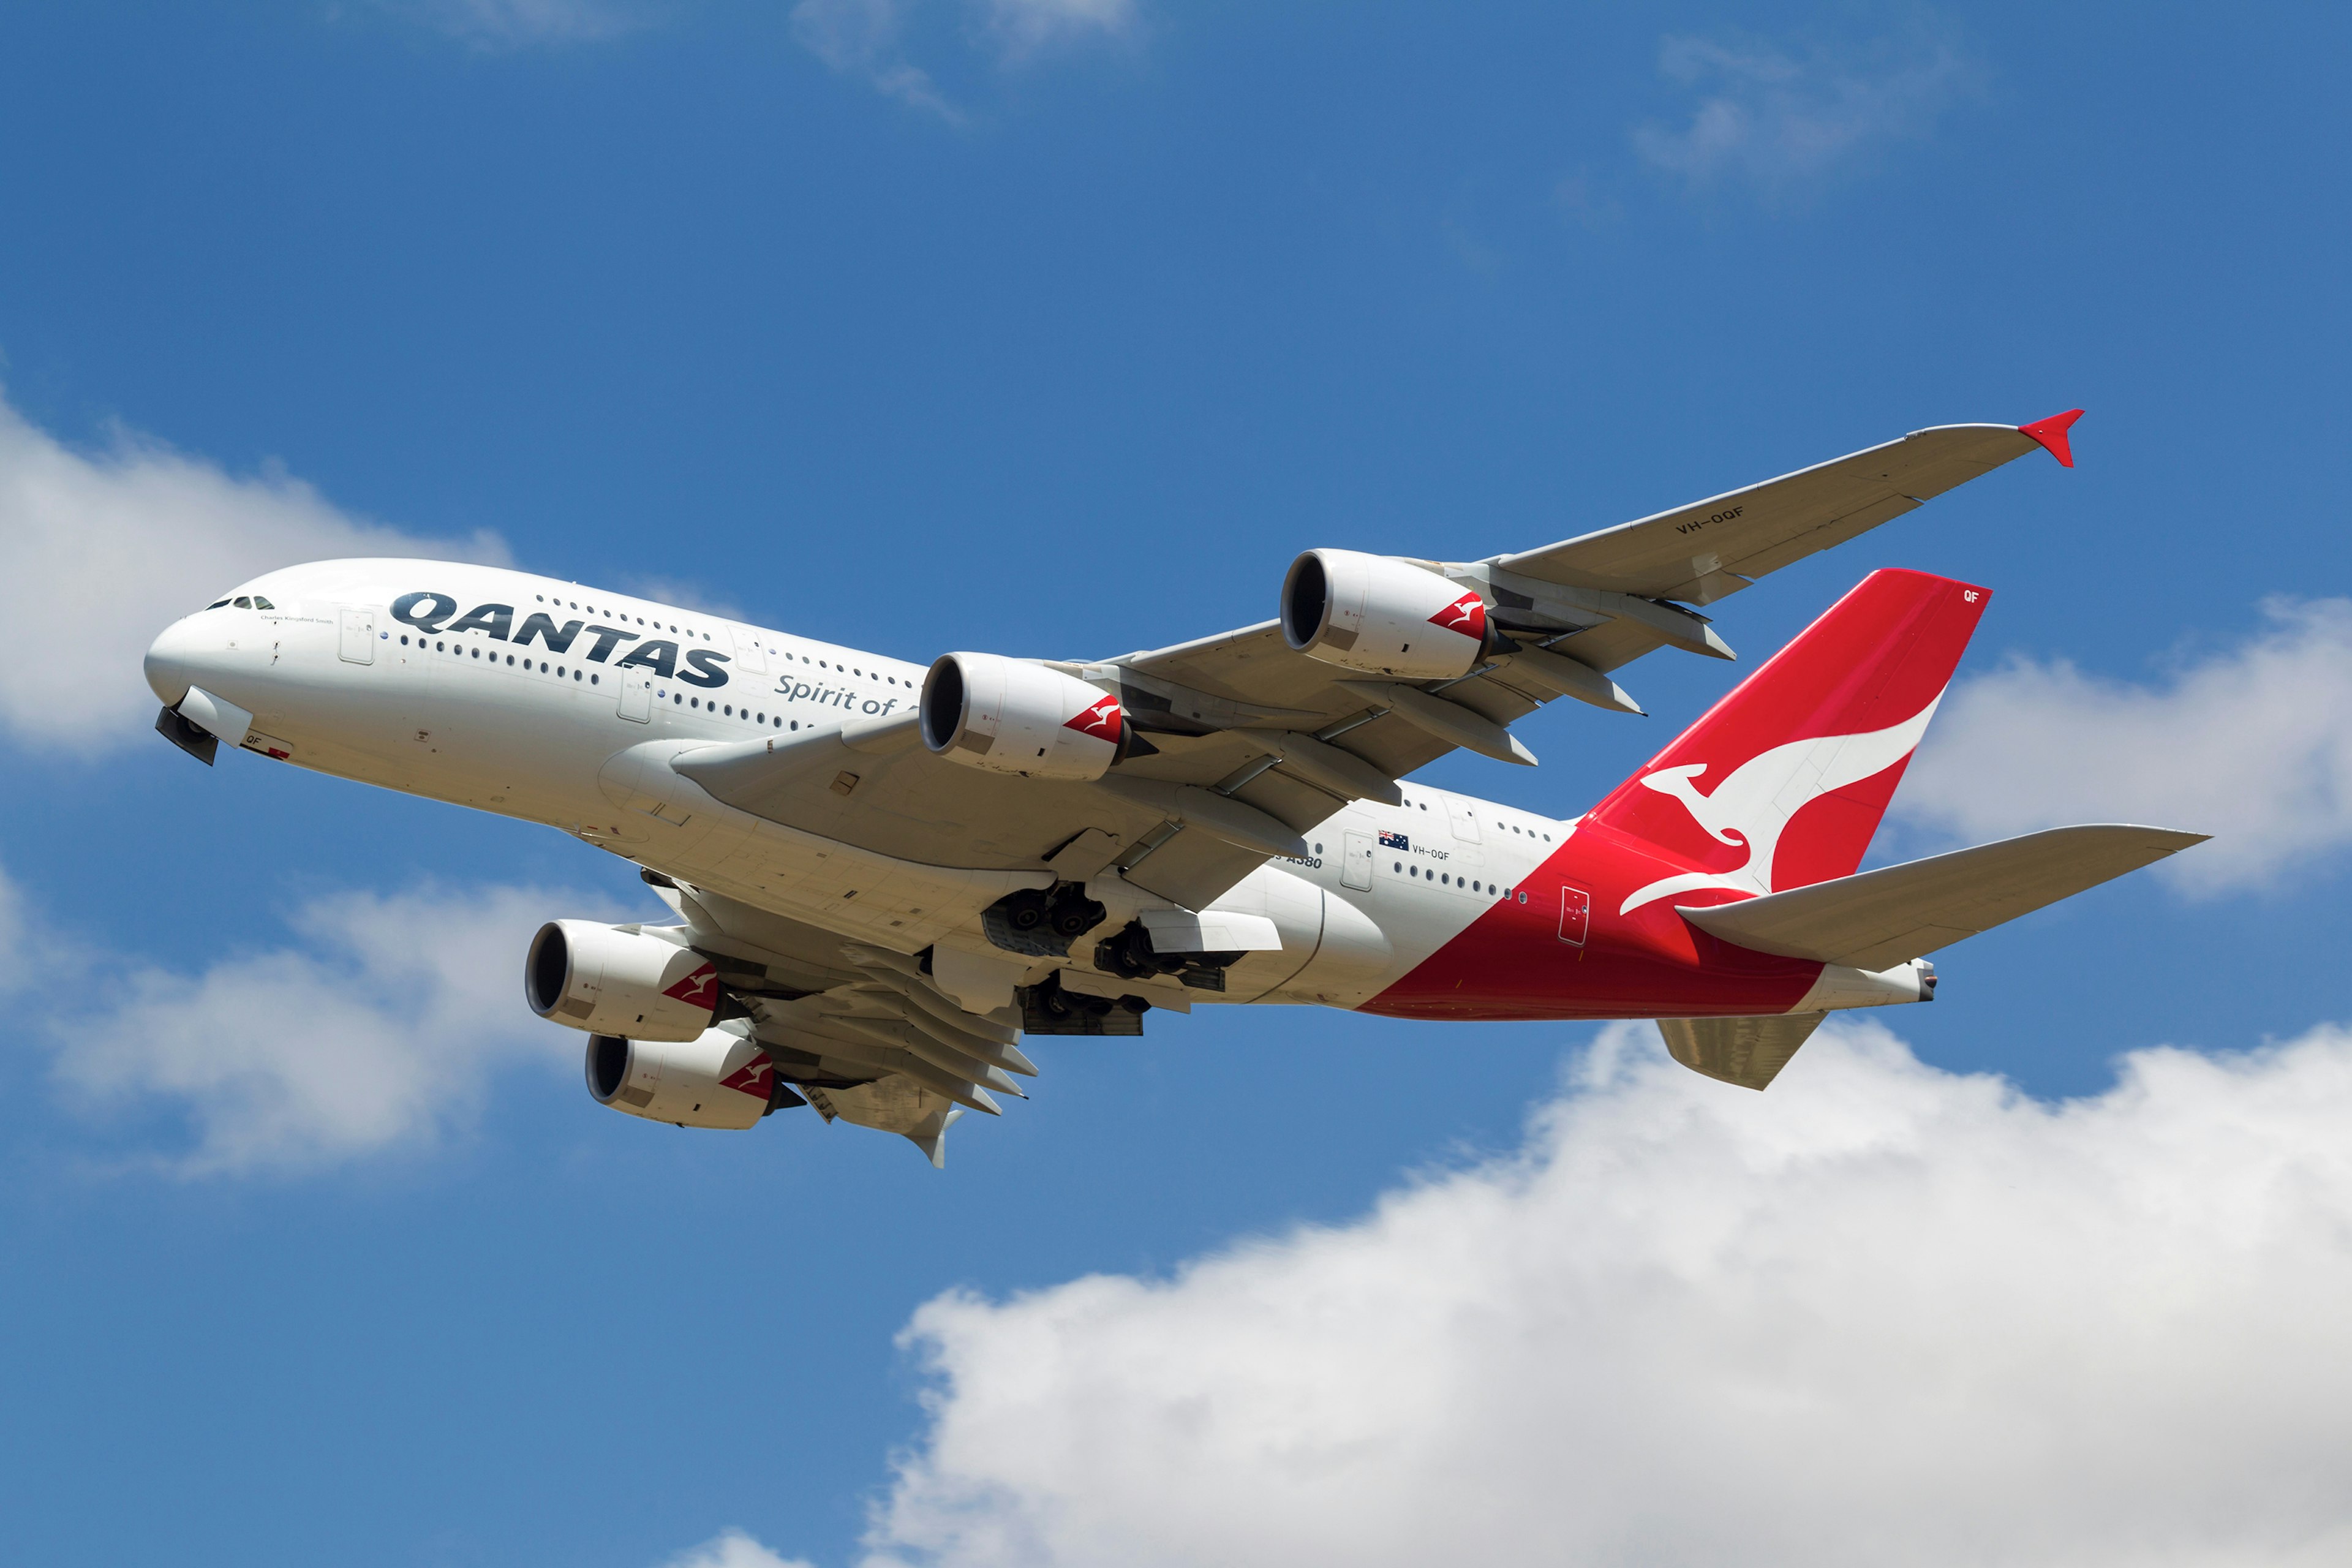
[922,654,1129,780]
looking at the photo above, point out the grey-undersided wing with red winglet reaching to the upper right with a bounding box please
[677,414,2072,910]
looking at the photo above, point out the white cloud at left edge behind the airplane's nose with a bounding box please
[0,398,506,755]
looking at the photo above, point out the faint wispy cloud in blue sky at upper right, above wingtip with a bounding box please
[1635,26,1973,193]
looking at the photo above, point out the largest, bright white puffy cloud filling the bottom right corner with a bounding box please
[870,1023,2352,1568]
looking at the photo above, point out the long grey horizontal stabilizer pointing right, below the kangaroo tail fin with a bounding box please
[1679,823,2209,968]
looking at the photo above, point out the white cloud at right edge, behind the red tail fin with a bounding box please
[1896,600,2352,893]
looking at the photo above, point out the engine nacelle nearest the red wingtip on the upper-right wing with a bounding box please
[1282,550,1489,679]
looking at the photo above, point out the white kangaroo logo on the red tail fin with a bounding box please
[1618,691,1943,914]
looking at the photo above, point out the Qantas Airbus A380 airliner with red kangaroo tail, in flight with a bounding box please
[146,409,2201,1164]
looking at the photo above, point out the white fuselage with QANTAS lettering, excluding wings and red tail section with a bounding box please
[148,559,1574,1006]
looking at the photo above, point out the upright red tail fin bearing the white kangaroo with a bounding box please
[1585,571,1992,910]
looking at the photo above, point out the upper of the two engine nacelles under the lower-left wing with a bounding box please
[522,919,720,1041]
